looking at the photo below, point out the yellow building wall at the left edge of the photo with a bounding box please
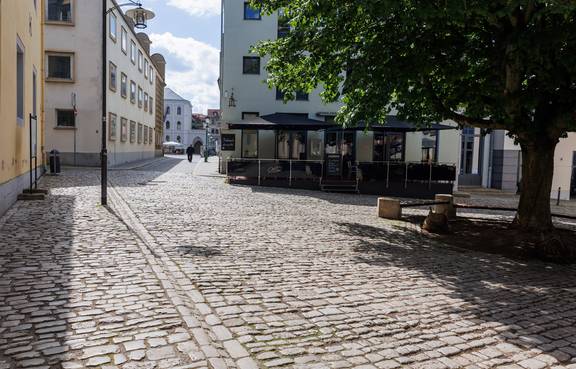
[0,0,44,215]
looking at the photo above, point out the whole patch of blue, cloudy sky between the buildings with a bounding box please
[145,0,220,114]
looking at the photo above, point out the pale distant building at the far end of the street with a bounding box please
[164,88,206,154]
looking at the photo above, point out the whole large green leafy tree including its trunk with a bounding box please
[254,0,576,230]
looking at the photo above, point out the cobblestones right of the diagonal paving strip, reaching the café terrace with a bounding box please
[114,157,576,368]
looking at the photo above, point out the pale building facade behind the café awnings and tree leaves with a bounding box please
[219,0,460,197]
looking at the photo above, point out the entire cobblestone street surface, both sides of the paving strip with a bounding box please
[0,154,576,369]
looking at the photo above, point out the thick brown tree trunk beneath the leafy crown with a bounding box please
[513,138,558,232]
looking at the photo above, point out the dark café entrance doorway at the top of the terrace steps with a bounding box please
[324,131,356,180]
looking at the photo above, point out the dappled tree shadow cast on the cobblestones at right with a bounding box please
[338,223,576,362]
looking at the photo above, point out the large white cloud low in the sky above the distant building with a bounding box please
[150,32,220,114]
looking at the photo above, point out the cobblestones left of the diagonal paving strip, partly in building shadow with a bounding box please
[0,162,232,369]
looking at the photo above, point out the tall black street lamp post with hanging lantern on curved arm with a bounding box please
[100,0,154,206]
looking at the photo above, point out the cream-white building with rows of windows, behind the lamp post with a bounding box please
[45,0,158,166]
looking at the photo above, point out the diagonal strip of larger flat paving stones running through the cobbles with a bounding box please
[109,181,259,369]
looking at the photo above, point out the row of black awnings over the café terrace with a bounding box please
[228,113,457,132]
